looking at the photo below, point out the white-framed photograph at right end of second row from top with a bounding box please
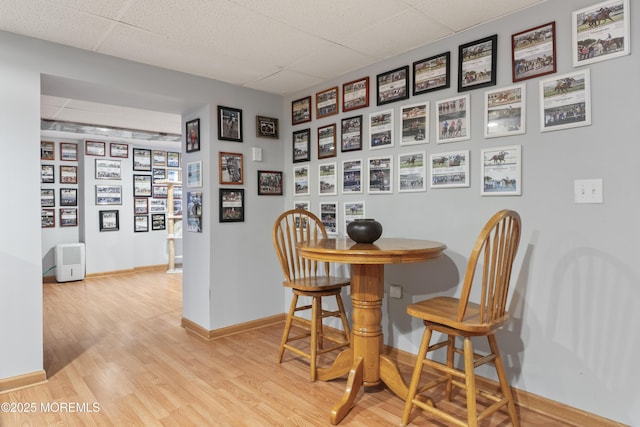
[540,68,591,132]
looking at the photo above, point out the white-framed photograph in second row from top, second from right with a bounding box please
[484,84,527,138]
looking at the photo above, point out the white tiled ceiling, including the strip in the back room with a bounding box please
[0,0,545,133]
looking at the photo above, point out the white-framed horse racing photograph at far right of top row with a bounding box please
[571,0,631,67]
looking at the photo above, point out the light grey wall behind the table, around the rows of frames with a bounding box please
[284,0,640,424]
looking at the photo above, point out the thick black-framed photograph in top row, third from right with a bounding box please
[458,34,498,92]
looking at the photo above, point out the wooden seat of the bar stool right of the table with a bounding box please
[407,297,509,335]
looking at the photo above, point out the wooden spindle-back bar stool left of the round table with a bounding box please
[272,209,350,381]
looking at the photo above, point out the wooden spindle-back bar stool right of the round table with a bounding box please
[402,210,521,426]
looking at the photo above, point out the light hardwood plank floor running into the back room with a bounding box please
[0,271,568,427]
